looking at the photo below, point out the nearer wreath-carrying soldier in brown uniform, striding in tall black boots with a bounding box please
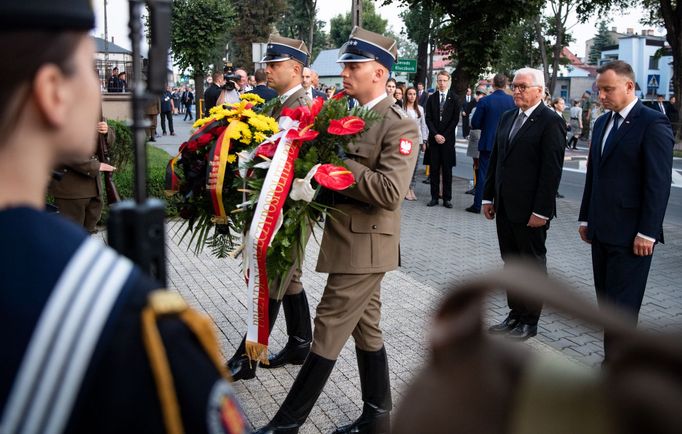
[258,27,419,433]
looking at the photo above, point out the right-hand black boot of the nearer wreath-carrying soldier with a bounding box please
[334,347,393,434]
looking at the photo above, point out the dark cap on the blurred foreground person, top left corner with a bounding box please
[0,0,95,32]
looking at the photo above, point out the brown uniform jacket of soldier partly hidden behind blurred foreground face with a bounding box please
[48,128,116,199]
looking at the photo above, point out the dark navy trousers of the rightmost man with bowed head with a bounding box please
[591,238,653,353]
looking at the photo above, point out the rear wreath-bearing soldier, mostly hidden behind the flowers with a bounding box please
[228,36,313,380]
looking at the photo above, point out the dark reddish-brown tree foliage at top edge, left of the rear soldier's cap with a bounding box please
[227,0,286,71]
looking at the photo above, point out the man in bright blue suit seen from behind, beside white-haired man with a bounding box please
[466,74,516,214]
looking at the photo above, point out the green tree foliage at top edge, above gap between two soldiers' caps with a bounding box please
[277,0,328,58]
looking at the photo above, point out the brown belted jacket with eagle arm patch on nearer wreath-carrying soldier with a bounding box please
[317,98,419,274]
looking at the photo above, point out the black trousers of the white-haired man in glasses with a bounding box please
[495,206,549,325]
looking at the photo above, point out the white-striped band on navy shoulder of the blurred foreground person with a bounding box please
[2,239,133,433]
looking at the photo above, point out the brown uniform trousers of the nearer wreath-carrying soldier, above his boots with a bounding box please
[311,273,385,360]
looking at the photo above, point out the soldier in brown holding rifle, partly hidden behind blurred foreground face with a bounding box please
[48,121,116,234]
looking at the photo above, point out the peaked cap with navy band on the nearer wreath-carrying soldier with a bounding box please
[336,26,398,71]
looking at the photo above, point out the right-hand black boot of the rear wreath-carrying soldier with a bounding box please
[263,291,313,369]
